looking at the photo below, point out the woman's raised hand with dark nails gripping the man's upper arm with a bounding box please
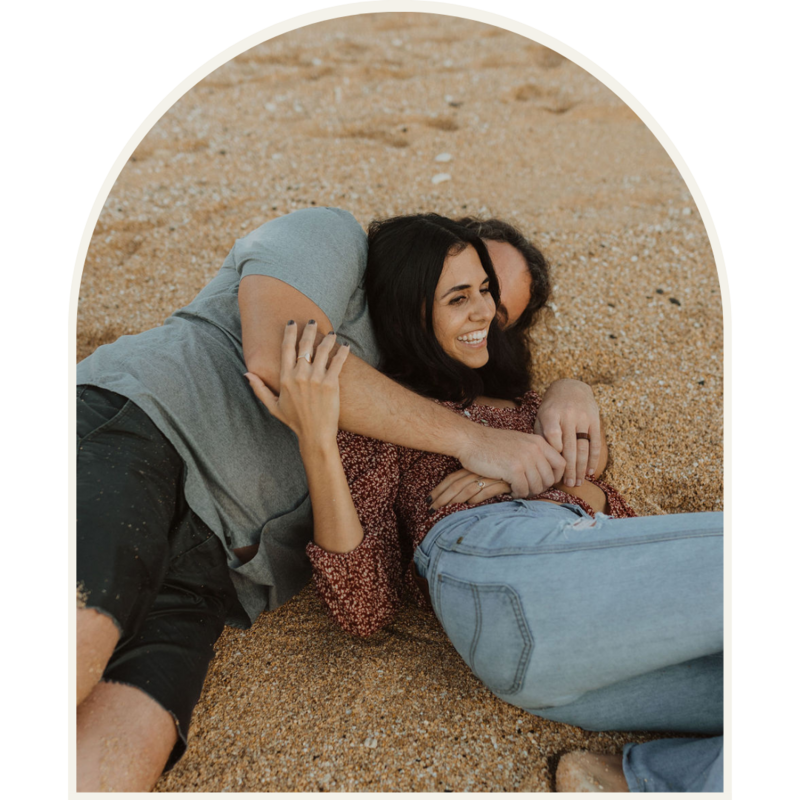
[245,320,350,445]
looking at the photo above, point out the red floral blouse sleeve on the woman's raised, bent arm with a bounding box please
[306,432,406,636]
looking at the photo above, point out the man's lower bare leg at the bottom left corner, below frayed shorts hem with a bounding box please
[77,683,178,792]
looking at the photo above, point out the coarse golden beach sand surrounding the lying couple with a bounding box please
[77,13,723,792]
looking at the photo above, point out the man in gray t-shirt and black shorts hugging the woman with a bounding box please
[77,208,600,791]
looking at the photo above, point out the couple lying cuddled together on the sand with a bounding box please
[77,208,723,791]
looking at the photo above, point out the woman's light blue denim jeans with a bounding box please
[414,500,723,791]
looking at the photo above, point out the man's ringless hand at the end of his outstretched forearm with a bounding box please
[456,423,566,498]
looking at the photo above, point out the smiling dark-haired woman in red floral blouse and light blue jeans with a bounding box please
[245,215,722,790]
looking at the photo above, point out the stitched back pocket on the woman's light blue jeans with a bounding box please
[435,573,534,695]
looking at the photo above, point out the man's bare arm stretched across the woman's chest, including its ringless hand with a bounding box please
[239,275,564,497]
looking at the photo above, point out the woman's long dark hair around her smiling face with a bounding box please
[366,214,531,406]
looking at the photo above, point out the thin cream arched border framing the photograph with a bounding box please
[67,0,733,797]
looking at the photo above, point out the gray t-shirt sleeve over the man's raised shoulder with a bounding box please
[231,208,367,329]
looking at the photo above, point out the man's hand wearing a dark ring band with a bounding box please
[533,379,604,487]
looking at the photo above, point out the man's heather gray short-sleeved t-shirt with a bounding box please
[77,208,377,624]
